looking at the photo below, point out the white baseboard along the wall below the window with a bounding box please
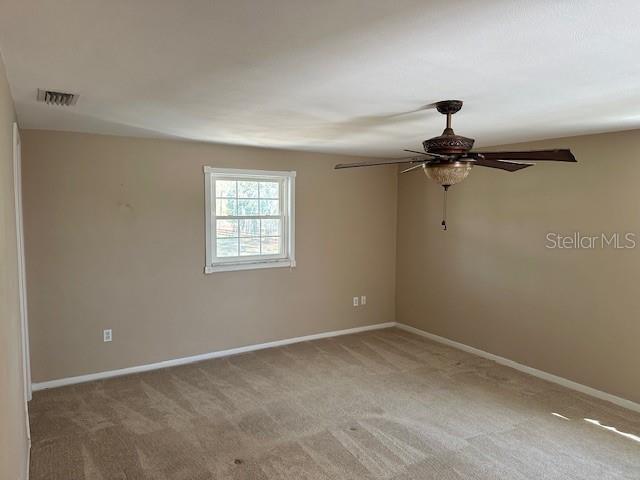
[32,322,396,392]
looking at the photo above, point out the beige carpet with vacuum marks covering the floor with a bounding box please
[31,329,640,480]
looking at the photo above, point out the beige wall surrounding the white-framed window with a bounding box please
[23,131,397,382]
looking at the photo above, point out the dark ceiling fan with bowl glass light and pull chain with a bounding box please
[335,100,576,230]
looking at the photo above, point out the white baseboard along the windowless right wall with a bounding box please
[396,323,640,412]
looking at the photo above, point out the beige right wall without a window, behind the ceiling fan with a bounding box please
[397,127,640,402]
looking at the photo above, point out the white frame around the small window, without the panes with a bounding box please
[204,166,296,273]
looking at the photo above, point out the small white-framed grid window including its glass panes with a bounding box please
[204,167,296,273]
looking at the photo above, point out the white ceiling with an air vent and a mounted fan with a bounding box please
[0,0,640,156]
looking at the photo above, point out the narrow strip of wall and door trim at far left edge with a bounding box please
[0,58,28,480]
